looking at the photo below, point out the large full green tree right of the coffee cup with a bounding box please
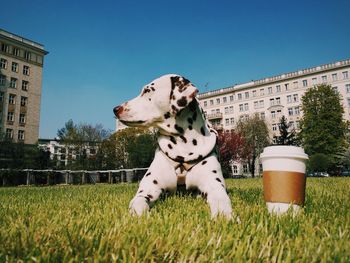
[300,84,346,172]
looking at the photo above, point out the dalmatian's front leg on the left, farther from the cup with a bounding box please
[129,150,177,216]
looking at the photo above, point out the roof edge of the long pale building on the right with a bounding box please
[198,59,350,99]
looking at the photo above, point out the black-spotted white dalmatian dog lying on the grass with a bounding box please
[113,74,232,219]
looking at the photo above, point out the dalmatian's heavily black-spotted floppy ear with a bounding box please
[170,76,198,114]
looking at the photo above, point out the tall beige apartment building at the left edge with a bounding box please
[0,29,48,144]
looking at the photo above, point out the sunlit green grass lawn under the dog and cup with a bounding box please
[0,178,350,262]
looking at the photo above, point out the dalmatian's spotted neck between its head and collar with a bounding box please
[158,99,217,163]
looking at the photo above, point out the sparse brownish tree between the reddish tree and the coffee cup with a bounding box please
[237,114,270,177]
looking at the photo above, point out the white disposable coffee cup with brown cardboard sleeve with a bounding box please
[260,145,308,215]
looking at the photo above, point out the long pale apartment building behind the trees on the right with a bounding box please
[198,59,350,140]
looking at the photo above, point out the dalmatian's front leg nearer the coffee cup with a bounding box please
[186,155,232,219]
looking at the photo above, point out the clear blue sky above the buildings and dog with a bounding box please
[0,0,350,138]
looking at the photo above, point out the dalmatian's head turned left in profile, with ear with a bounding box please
[113,74,198,126]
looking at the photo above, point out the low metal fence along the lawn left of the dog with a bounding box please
[0,168,148,186]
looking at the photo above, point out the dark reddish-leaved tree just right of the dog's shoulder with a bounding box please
[218,131,244,177]
